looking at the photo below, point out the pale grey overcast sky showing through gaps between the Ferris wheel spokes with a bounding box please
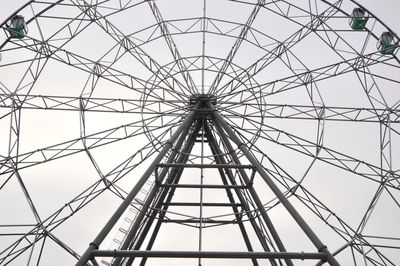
[0,0,400,265]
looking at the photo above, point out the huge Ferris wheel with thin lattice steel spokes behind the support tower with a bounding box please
[0,1,400,265]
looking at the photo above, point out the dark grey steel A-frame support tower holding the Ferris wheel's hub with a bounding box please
[76,94,339,266]
